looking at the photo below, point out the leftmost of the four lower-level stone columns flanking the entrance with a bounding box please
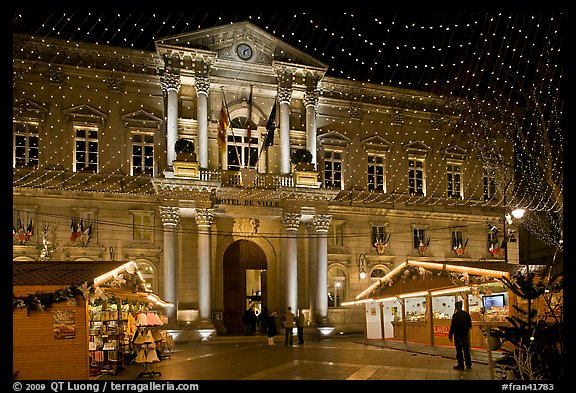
[160,206,180,326]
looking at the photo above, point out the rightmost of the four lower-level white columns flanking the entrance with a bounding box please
[314,214,332,325]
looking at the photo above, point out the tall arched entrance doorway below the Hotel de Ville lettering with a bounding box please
[223,240,267,334]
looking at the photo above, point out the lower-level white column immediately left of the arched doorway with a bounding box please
[195,209,214,321]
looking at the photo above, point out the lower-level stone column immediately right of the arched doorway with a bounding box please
[282,212,302,312]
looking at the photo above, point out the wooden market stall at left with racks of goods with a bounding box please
[12,261,169,380]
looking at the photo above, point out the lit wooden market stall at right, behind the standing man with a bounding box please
[343,260,520,347]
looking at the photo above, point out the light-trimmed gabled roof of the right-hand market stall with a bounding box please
[342,260,523,306]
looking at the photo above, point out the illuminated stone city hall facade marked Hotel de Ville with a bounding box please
[12,22,517,334]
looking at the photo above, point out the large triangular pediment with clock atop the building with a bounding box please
[156,21,327,72]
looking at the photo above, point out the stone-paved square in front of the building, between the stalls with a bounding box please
[98,335,508,381]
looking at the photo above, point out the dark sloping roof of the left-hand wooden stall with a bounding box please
[12,261,132,285]
